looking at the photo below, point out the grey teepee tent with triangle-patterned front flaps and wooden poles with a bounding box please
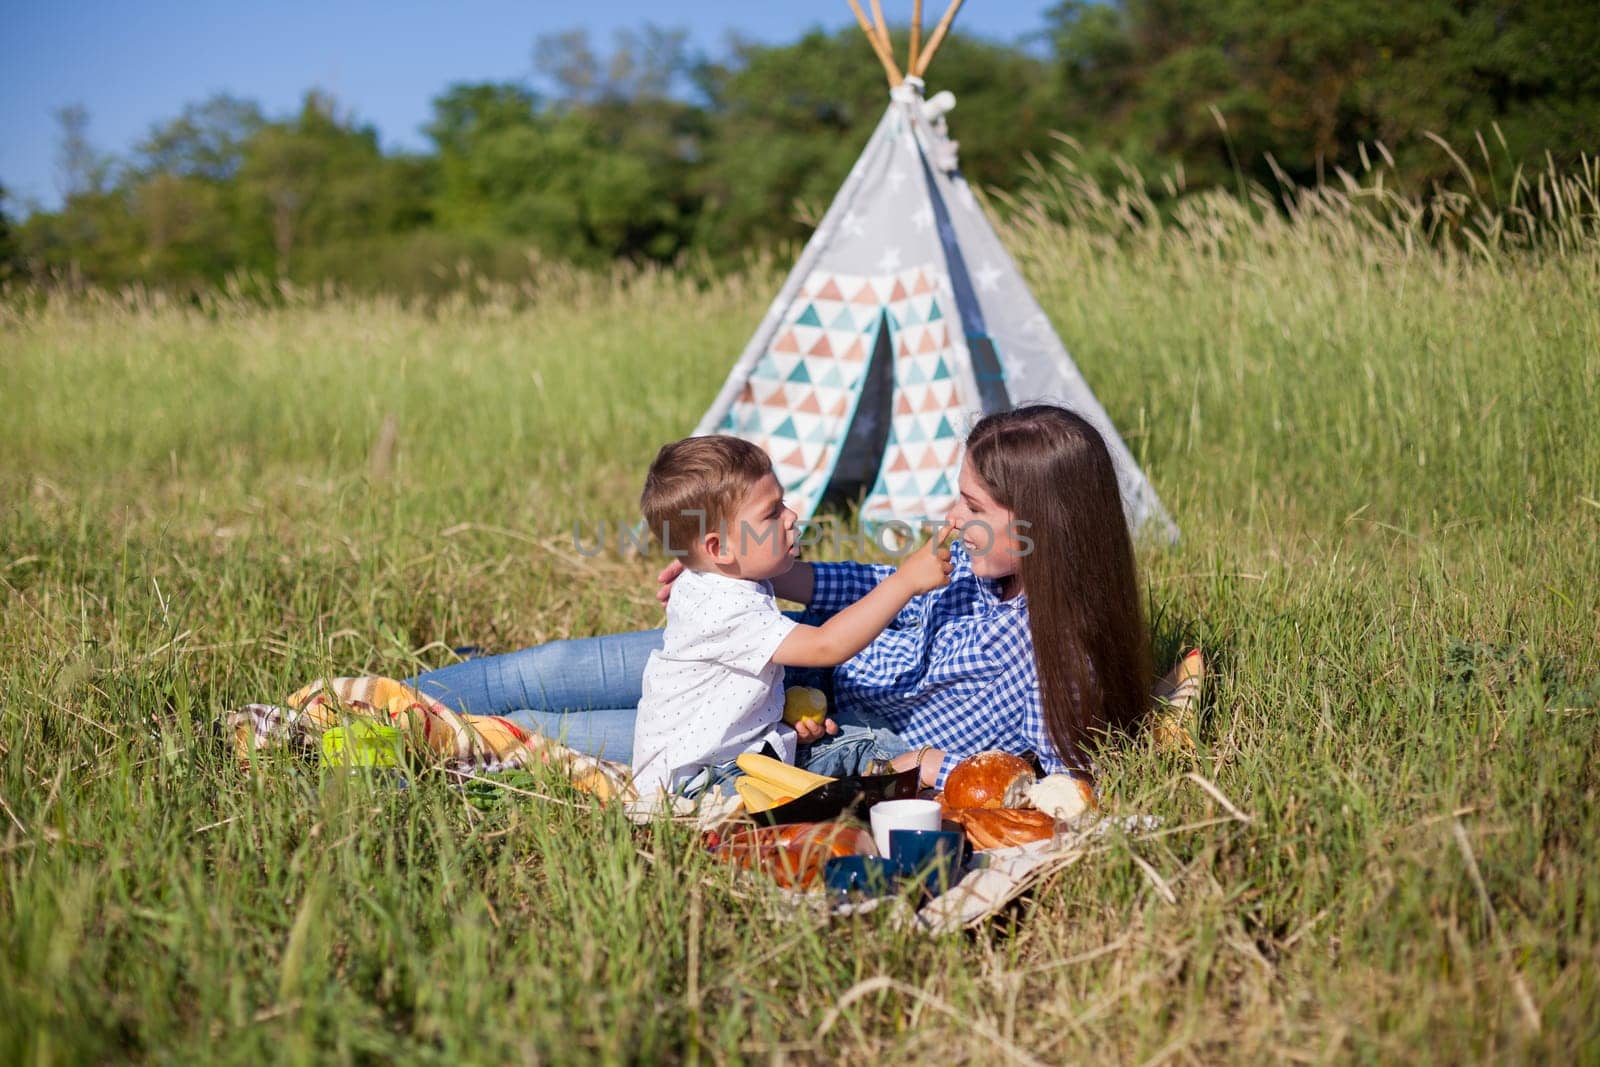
[694,0,1178,539]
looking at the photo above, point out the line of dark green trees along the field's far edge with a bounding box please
[0,0,1600,290]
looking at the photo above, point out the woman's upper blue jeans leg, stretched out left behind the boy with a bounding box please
[411,630,662,723]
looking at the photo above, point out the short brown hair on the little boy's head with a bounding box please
[638,434,773,553]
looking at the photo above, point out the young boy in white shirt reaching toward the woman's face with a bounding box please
[634,435,950,797]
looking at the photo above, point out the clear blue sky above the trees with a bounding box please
[0,0,1054,216]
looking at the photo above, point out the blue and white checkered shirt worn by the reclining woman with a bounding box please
[810,541,1067,784]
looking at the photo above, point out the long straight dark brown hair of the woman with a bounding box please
[966,405,1150,771]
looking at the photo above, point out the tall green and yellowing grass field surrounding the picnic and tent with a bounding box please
[9,154,1600,1064]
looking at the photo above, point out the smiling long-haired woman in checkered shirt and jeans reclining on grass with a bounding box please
[414,405,1150,785]
